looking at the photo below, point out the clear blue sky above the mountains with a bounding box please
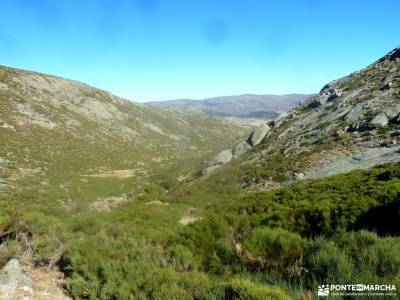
[0,0,400,101]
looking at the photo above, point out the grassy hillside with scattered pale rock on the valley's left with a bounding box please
[0,67,245,206]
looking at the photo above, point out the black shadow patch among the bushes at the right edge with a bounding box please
[355,199,400,236]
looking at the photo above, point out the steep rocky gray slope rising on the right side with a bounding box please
[202,48,400,189]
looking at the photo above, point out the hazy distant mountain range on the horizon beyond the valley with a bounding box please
[147,94,312,119]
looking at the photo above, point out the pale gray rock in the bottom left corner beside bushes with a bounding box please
[0,259,33,300]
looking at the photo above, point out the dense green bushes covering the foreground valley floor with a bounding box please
[0,164,400,300]
